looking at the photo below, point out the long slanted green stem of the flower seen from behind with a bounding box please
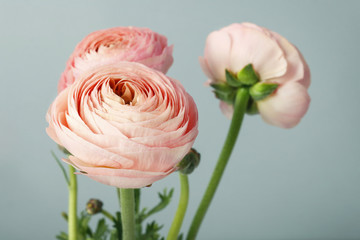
[187,88,249,240]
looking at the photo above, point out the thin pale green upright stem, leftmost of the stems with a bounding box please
[68,166,77,240]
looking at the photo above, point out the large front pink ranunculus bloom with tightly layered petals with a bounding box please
[47,62,198,188]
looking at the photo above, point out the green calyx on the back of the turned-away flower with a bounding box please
[211,63,279,114]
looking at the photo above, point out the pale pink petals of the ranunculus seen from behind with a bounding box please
[200,23,310,128]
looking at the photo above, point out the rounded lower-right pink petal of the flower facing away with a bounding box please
[258,82,310,128]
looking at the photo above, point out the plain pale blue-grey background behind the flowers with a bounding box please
[0,0,360,240]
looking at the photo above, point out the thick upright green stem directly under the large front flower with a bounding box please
[120,188,135,240]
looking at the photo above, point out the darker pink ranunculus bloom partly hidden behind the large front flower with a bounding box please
[58,27,173,92]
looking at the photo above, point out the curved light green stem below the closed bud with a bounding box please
[166,173,189,240]
